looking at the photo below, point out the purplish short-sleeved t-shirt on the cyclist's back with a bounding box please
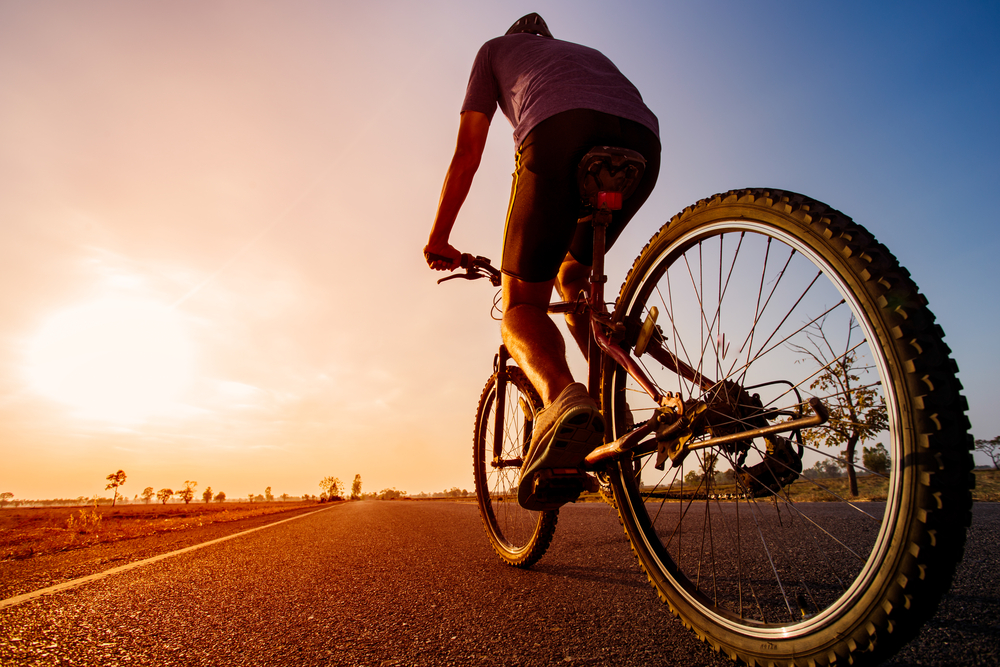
[462,33,659,146]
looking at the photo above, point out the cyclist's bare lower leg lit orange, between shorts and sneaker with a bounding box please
[500,274,573,405]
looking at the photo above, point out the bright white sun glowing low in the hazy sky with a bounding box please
[28,299,192,422]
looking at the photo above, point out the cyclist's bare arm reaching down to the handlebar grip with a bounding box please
[424,111,490,271]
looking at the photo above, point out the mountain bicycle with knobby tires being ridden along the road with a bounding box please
[439,147,974,665]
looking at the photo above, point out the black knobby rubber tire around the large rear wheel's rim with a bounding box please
[615,188,974,665]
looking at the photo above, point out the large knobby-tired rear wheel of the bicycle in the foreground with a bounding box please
[596,189,973,665]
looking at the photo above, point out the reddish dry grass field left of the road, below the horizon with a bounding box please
[0,503,313,560]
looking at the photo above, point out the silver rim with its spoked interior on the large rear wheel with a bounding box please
[611,220,903,639]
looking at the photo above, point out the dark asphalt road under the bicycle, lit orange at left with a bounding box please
[0,501,1000,666]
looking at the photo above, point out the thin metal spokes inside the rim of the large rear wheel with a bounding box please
[608,218,900,624]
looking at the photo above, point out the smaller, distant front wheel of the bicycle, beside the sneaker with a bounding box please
[473,366,559,567]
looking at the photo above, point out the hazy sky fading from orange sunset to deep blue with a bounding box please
[0,0,1000,499]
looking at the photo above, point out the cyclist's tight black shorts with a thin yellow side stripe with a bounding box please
[501,109,660,283]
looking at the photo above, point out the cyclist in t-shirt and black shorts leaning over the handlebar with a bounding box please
[424,14,660,509]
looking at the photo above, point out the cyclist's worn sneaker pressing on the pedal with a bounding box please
[517,382,604,511]
